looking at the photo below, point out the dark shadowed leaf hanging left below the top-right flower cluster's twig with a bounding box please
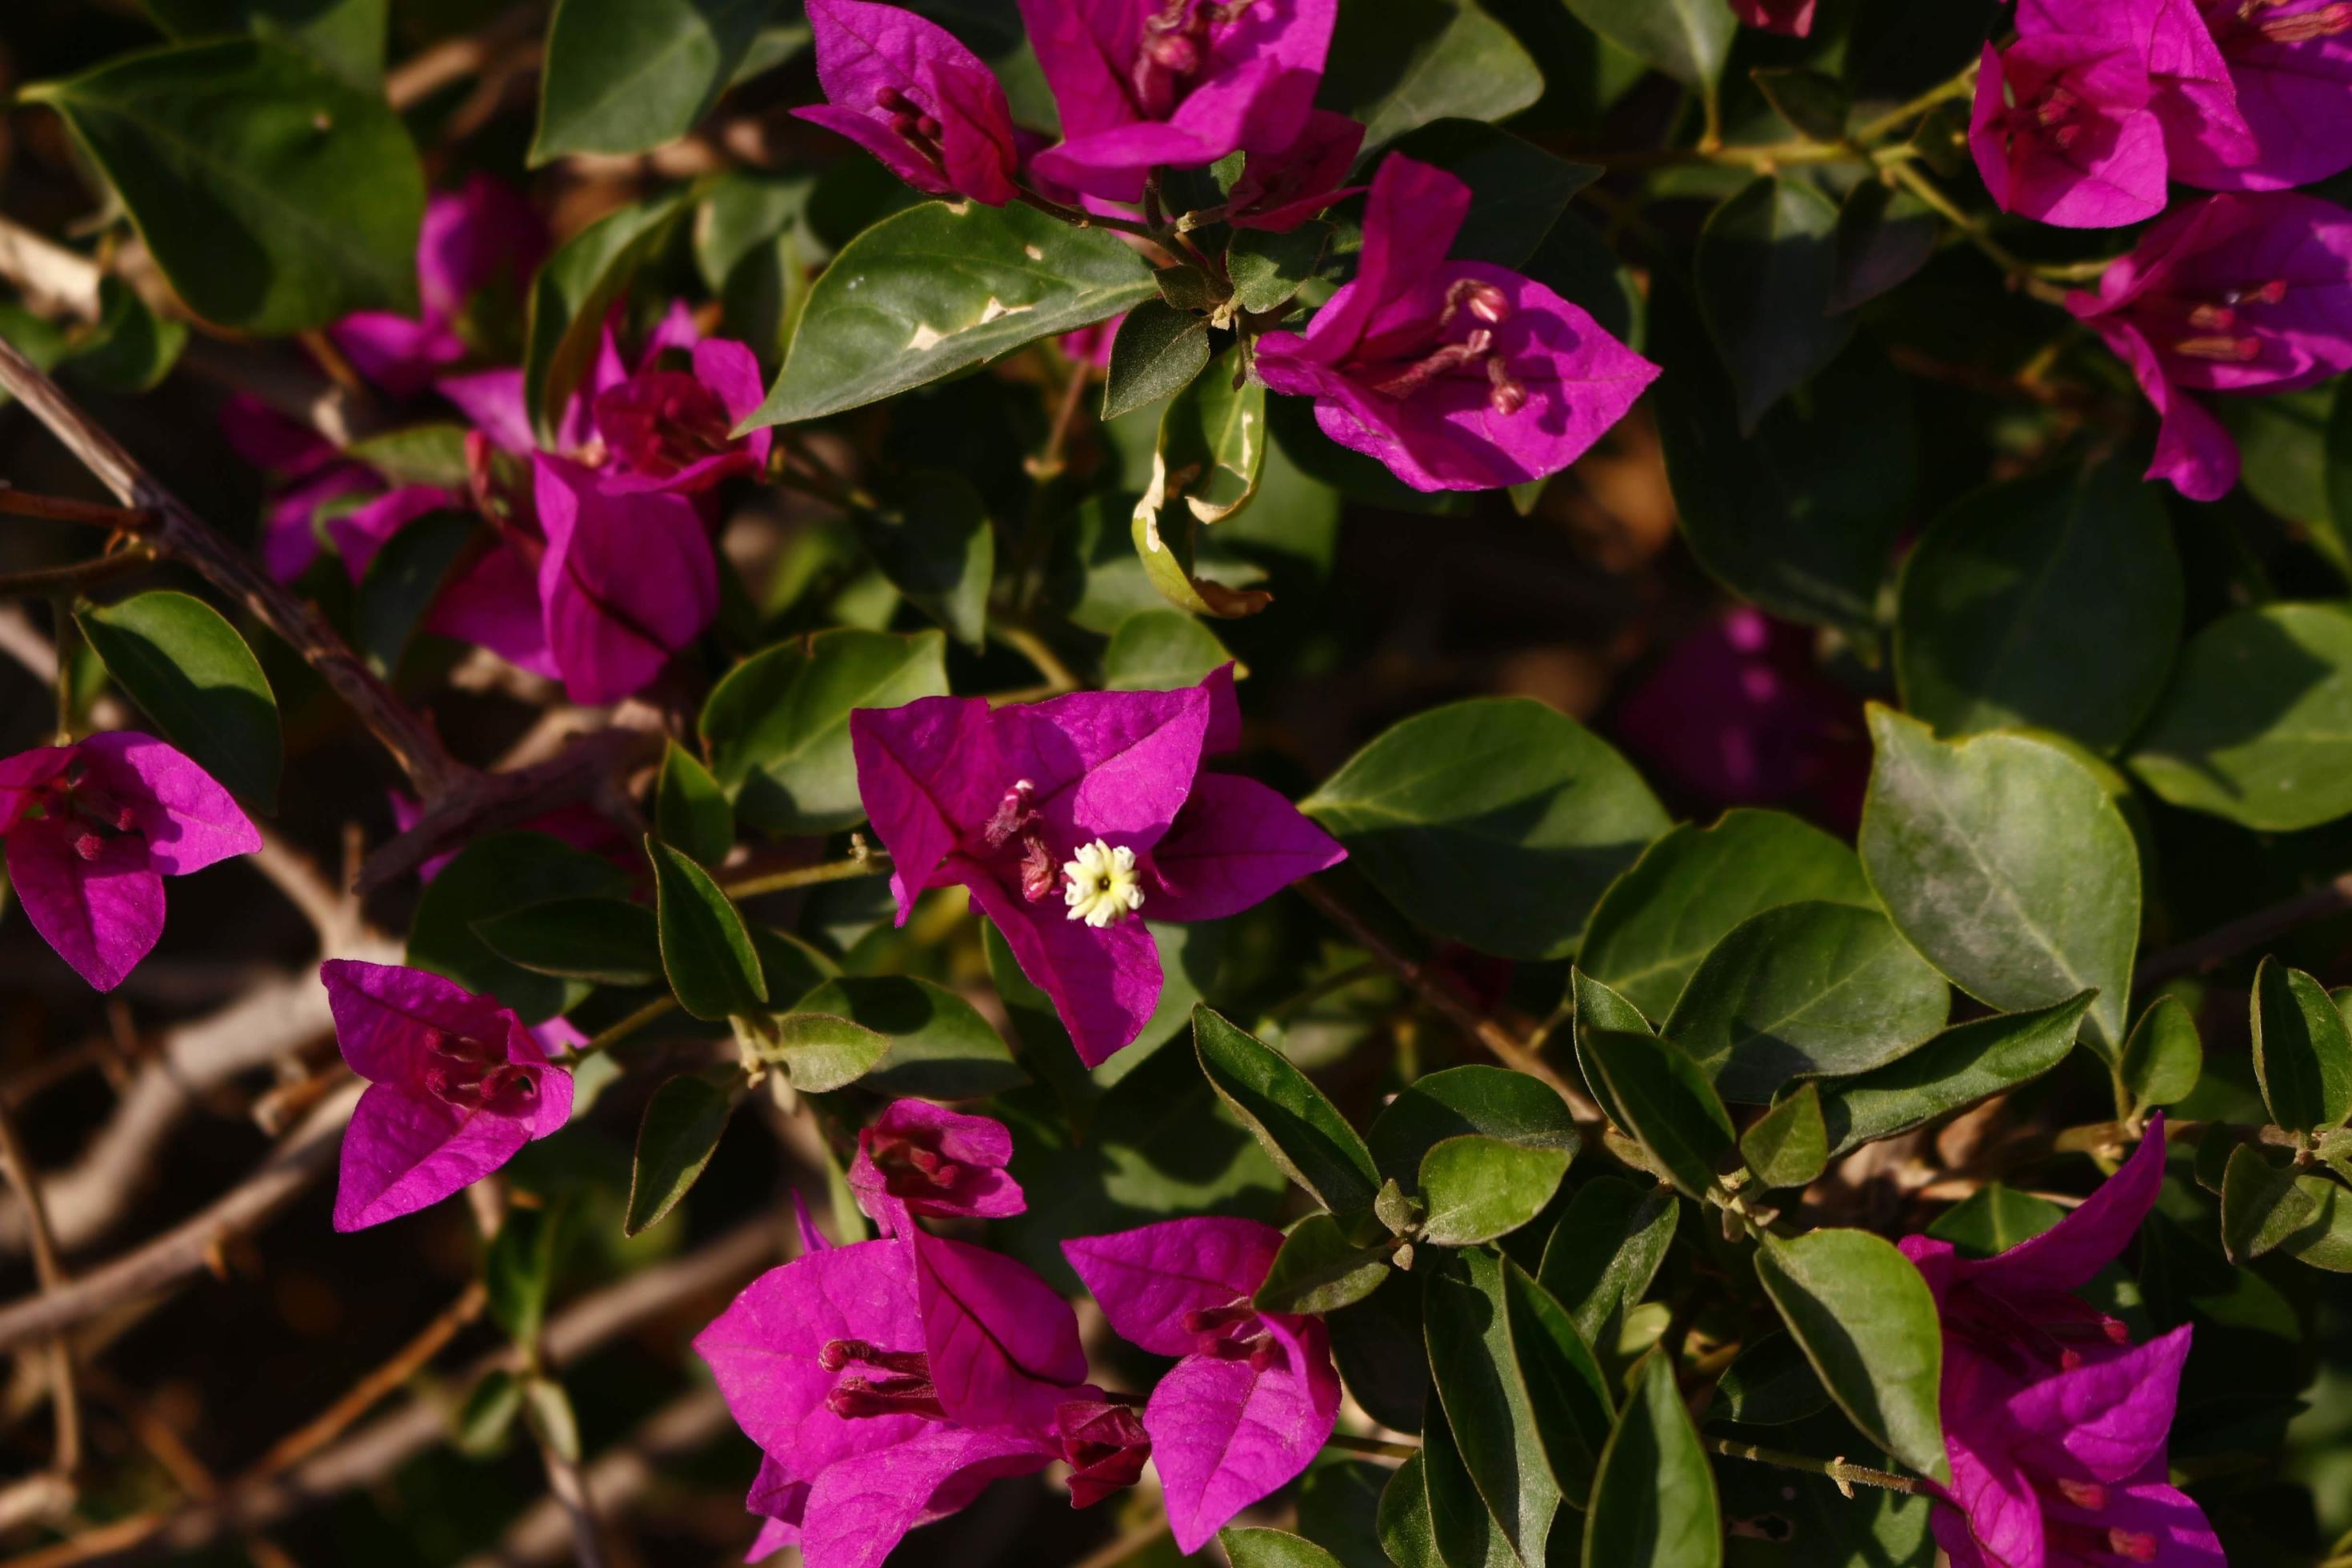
[1702,179,1854,433]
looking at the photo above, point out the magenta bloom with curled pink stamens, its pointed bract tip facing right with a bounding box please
[1258,153,1658,491]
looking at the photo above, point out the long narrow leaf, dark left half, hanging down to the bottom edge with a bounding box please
[1421,1250,1559,1563]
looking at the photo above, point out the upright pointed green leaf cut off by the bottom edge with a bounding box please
[1583,1354,1729,1568]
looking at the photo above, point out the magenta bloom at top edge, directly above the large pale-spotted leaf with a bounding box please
[793,0,1021,207]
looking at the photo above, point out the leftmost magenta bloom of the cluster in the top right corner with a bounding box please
[1969,33,2164,228]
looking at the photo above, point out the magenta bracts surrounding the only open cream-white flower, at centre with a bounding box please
[849,668,1346,1065]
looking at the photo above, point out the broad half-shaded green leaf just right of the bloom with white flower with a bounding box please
[1298,698,1667,959]
